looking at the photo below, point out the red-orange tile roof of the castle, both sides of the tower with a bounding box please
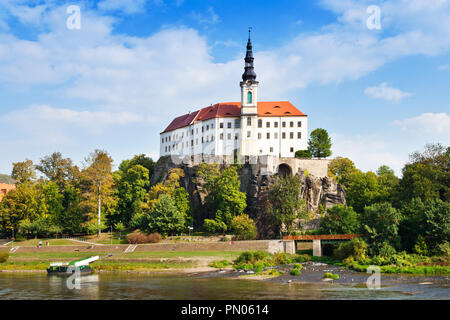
[162,101,306,133]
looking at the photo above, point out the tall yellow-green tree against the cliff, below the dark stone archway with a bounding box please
[268,176,307,234]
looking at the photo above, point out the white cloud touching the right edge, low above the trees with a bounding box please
[394,112,450,136]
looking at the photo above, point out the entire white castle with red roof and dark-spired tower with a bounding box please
[160,32,308,161]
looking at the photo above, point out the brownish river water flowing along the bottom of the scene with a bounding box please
[0,273,450,300]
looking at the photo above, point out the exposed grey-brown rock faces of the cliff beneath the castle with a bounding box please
[151,157,346,237]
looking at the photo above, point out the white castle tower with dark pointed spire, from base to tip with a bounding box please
[240,28,258,156]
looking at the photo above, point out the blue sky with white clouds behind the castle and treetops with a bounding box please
[0,0,450,175]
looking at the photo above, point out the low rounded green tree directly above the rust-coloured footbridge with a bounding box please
[319,204,359,234]
